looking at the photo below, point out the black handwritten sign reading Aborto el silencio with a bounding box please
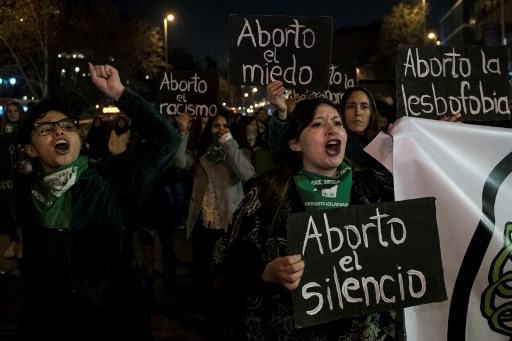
[287,198,447,328]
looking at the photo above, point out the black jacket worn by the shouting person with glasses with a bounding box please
[17,89,180,340]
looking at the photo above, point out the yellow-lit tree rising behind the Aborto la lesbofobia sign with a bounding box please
[376,2,429,79]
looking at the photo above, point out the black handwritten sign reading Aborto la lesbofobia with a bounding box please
[396,46,510,121]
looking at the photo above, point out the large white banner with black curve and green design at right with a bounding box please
[370,117,512,341]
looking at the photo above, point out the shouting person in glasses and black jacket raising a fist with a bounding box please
[17,64,179,340]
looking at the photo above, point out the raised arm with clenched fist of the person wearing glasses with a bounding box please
[89,64,181,206]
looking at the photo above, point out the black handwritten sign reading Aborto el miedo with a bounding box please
[229,14,332,89]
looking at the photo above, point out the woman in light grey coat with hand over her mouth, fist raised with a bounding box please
[171,108,255,334]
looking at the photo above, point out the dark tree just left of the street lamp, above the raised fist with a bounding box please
[63,1,165,102]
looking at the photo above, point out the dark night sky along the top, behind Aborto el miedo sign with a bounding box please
[107,0,446,67]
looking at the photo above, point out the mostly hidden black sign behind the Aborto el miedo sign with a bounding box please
[292,62,357,104]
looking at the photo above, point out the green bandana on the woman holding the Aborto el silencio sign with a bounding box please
[293,162,352,211]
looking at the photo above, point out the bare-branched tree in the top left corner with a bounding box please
[0,0,62,98]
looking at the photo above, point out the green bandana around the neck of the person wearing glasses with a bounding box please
[32,156,88,228]
